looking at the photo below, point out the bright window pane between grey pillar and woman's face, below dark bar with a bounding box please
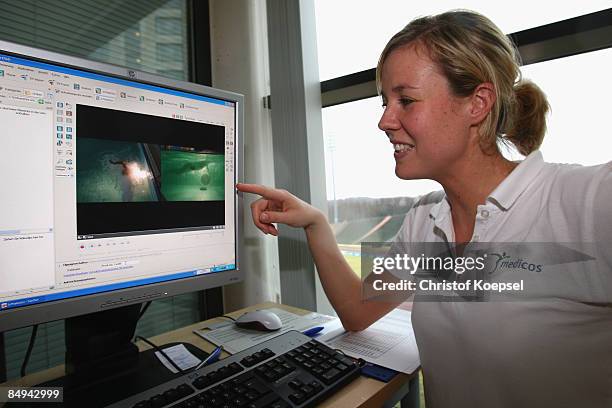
[323,97,441,275]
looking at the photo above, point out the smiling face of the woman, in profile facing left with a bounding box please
[378,45,471,181]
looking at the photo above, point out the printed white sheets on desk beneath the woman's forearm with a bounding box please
[317,309,421,374]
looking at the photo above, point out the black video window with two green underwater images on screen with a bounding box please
[76,105,225,239]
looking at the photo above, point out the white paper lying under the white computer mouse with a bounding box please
[193,308,338,354]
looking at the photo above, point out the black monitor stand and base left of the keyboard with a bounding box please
[39,305,208,407]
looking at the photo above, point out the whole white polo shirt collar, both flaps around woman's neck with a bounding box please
[429,150,544,221]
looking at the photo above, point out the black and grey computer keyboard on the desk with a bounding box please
[110,331,360,408]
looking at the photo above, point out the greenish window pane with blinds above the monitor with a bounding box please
[0,0,189,80]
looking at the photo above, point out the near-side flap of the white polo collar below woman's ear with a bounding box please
[487,150,544,210]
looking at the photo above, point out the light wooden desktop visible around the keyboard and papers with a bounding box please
[0,303,418,408]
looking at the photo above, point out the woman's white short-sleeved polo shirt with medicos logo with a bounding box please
[397,151,612,408]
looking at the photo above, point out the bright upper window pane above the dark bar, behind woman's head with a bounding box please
[315,0,611,81]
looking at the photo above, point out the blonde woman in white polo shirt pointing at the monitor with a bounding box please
[238,10,612,408]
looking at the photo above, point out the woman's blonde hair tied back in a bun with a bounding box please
[376,10,550,155]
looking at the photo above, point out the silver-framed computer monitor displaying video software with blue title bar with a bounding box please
[0,43,242,330]
